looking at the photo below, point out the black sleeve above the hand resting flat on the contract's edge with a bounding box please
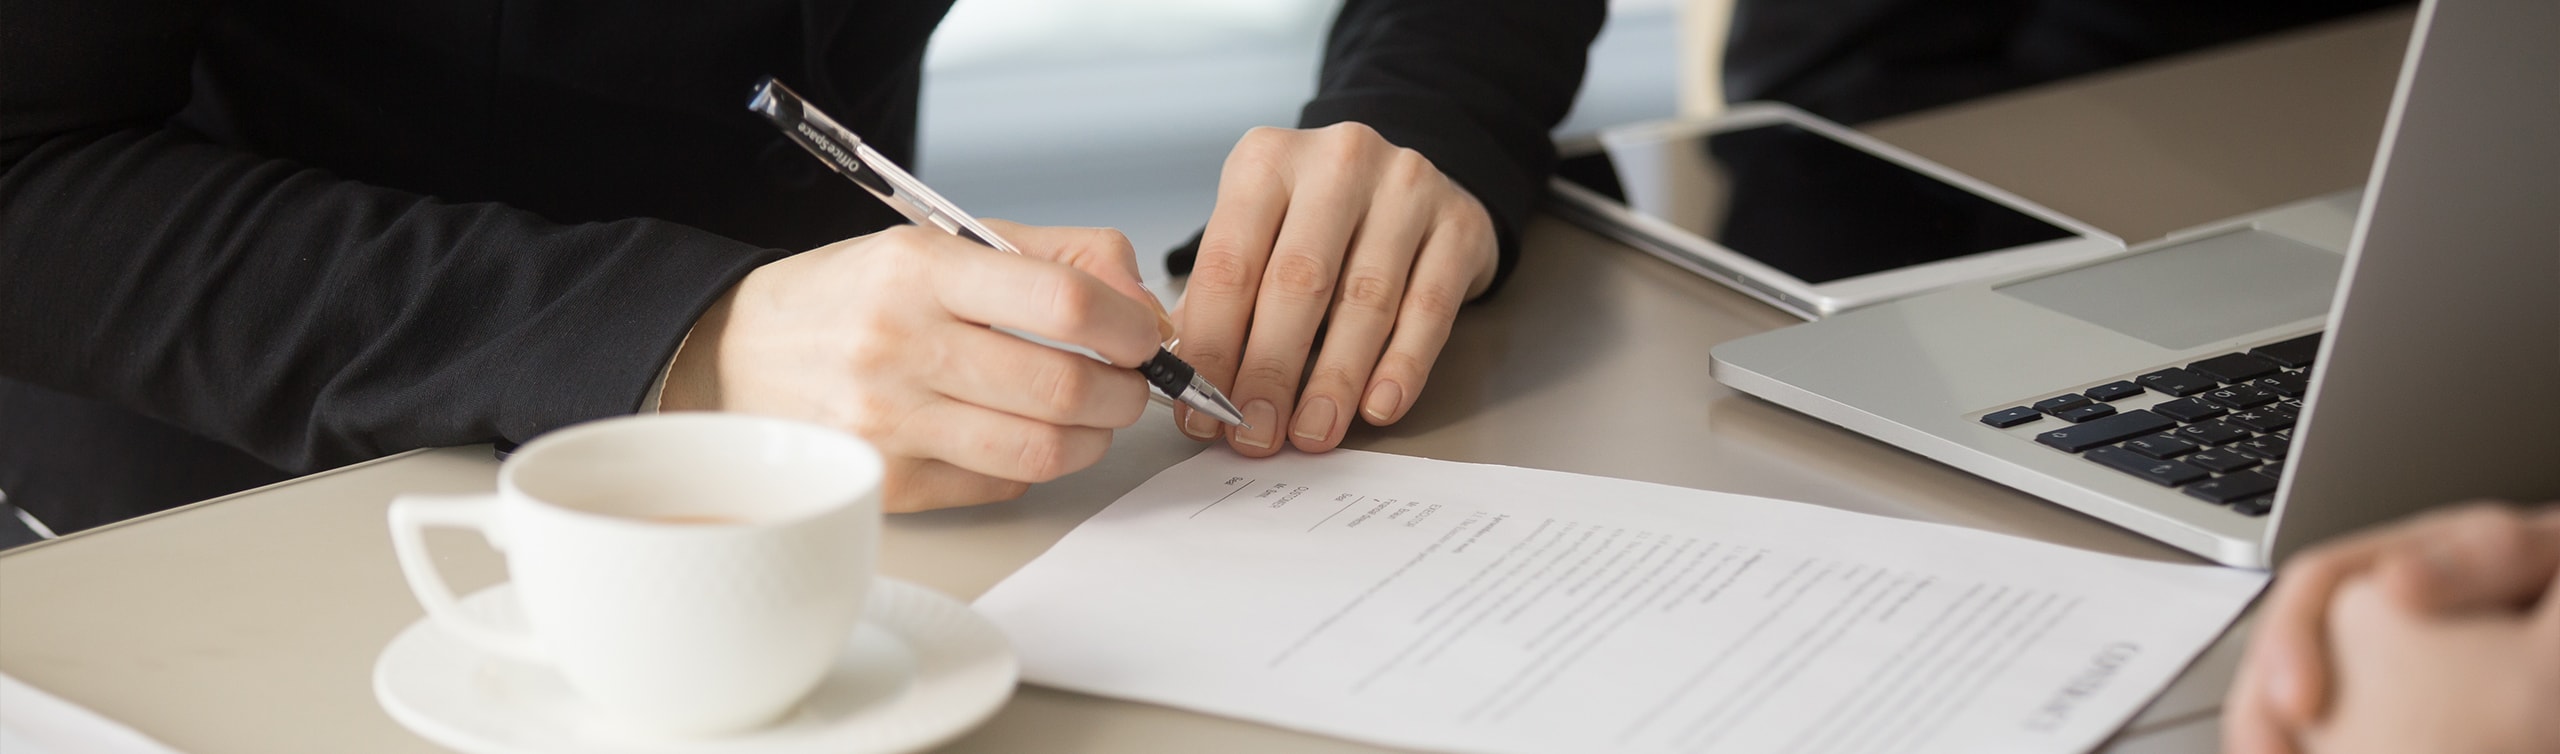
[1172,0,1608,296]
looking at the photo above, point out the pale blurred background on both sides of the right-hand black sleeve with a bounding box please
[914,0,1682,289]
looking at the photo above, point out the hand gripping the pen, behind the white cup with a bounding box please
[660,220,1167,511]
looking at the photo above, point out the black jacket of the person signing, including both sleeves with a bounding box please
[0,0,1603,529]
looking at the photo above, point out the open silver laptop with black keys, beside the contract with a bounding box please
[1713,0,2560,567]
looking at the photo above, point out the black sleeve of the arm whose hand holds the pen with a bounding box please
[0,0,781,470]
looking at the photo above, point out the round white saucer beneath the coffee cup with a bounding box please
[374,578,1019,754]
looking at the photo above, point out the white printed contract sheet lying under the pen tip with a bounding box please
[978,450,2266,754]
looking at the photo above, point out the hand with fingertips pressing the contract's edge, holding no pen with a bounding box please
[1175,123,1498,458]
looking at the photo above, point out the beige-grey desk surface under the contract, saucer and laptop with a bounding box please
[0,10,2409,754]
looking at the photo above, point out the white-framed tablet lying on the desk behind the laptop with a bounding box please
[1551,102,2125,319]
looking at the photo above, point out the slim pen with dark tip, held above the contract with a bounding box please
[748,77,1252,429]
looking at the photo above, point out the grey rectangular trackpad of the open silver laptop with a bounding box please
[1994,230,2345,350]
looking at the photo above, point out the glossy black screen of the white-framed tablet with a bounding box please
[1556,123,2071,284]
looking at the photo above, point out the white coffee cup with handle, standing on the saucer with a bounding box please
[392,414,881,736]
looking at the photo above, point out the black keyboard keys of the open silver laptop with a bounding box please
[1981,332,2319,516]
